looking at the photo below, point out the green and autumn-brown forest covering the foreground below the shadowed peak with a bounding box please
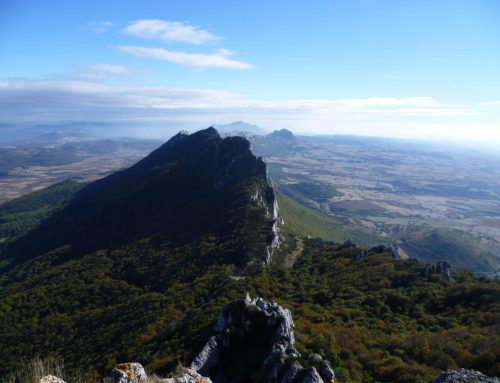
[0,239,500,382]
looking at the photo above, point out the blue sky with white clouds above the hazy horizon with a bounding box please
[0,0,500,144]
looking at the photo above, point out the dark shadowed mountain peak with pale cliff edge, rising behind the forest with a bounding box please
[3,128,277,272]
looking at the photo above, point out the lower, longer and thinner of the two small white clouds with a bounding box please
[118,45,253,69]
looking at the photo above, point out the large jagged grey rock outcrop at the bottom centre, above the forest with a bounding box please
[190,294,335,383]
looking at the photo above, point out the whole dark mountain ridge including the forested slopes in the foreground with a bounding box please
[0,129,500,383]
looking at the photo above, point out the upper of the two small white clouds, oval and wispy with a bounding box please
[123,19,220,45]
